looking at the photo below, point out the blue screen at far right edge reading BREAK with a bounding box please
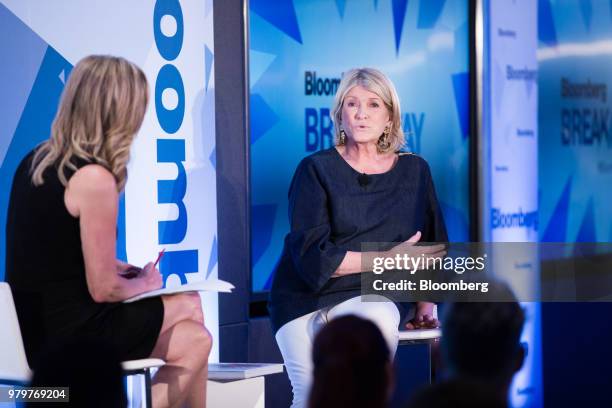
[538,0,612,242]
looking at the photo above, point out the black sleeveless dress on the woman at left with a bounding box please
[6,152,164,366]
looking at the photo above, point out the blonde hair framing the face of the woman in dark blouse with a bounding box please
[331,68,406,153]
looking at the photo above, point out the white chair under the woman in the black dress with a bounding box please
[0,282,166,407]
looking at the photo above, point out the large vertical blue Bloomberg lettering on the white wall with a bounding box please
[153,0,198,284]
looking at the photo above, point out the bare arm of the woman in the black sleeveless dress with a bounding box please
[64,164,162,302]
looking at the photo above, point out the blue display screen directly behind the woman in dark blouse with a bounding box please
[249,0,469,292]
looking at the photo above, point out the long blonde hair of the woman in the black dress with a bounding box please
[31,55,149,191]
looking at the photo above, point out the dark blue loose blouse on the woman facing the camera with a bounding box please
[268,147,448,332]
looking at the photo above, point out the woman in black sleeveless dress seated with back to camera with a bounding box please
[6,56,212,407]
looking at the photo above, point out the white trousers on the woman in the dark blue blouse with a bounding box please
[276,295,400,408]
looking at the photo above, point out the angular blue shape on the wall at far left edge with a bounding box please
[0,4,72,281]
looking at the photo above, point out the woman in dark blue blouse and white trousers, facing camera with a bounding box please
[269,68,447,407]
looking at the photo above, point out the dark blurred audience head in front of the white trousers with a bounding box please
[308,315,392,408]
